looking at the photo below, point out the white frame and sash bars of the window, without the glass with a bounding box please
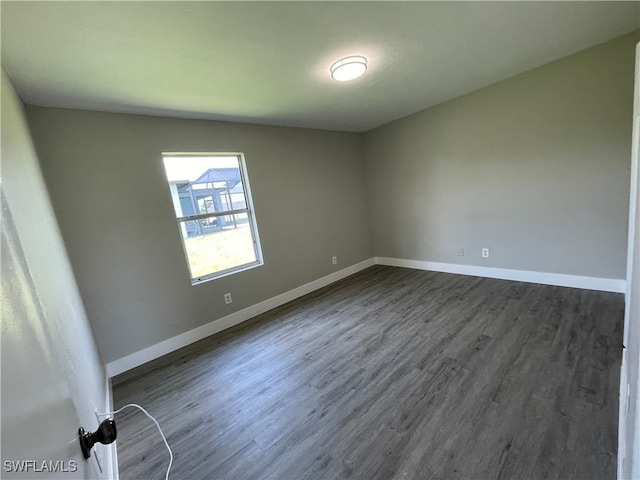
[162,152,264,285]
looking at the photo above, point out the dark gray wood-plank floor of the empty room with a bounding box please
[114,266,624,480]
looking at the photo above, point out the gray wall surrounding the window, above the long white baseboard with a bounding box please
[27,107,373,362]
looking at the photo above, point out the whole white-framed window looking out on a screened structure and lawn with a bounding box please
[163,153,262,285]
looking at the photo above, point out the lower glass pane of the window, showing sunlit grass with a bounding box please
[180,214,257,279]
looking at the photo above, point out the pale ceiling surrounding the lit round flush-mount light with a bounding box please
[1,1,640,132]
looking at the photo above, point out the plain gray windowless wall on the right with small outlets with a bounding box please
[365,33,638,279]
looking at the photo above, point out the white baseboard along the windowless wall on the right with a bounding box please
[375,257,627,293]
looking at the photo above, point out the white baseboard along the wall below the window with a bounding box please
[107,258,374,377]
